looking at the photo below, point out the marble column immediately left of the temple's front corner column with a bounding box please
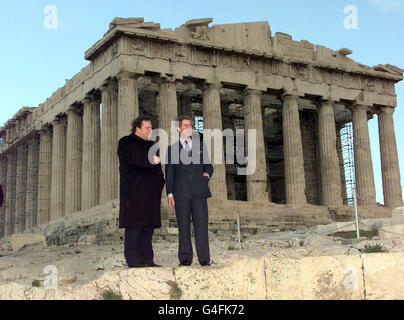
[100,80,119,204]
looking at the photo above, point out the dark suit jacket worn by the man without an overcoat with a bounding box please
[165,136,213,200]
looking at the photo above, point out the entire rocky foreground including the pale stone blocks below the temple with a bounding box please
[0,219,404,300]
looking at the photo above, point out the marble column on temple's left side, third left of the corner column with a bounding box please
[65,106,83,216]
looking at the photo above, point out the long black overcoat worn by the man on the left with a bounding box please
[118,133,165,228]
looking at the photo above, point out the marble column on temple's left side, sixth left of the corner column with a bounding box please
[25,135,39,231]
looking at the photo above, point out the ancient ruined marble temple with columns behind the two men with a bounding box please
[0,18,404,237]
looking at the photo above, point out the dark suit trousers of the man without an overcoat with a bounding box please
[175,198,210,263]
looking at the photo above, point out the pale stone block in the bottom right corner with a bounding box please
[362,252,404,300]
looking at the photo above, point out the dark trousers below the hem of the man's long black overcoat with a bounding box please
[124,226,155,267]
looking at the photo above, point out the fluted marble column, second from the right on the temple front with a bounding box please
[352,104,376,206]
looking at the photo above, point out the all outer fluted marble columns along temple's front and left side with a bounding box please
[0,76,402,235]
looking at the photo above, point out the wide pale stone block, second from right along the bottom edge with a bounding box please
[265,256,364,300]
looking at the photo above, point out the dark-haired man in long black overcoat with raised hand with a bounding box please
[118,117,165,268]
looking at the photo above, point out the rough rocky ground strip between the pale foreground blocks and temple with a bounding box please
[0,222,404,296]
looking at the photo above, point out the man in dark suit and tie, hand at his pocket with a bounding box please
[165,116,213,266]
